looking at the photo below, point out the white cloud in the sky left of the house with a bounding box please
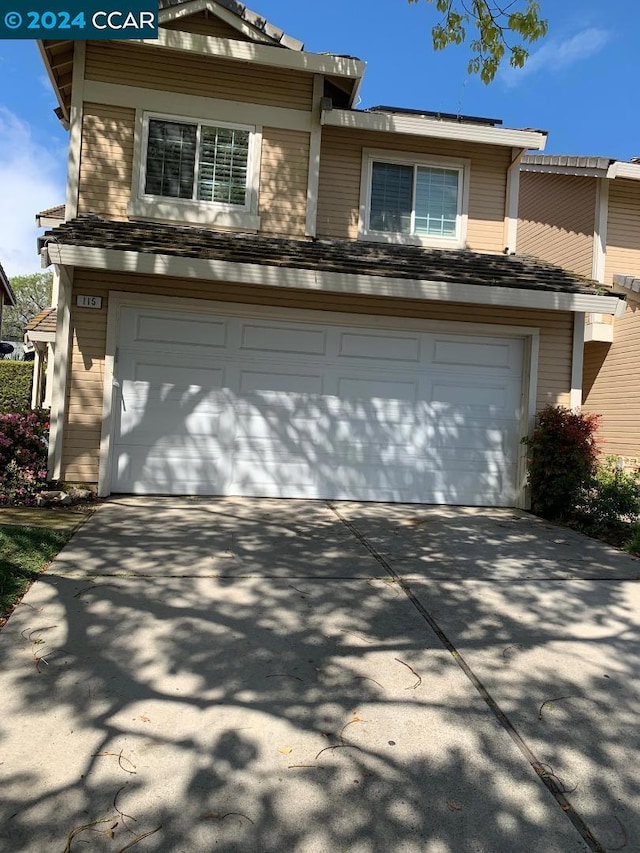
[0,106,65,276]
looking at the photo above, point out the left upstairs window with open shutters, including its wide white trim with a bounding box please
[129,113,261,230]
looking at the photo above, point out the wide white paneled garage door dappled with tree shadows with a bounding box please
[111,307,523,506]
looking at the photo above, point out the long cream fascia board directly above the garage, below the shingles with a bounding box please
[46,242,621,314]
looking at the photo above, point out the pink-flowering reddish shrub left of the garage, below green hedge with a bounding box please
[0,409,49,506]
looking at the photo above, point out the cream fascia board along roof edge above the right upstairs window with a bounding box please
[322,109,547,151]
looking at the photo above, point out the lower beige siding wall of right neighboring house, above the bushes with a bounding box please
[583,294,640,465]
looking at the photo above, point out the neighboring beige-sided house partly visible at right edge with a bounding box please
[518,154,640,469]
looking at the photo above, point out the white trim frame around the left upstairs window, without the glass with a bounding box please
[127,109,262,231]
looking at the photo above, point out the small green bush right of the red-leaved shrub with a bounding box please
[580,456,640,532]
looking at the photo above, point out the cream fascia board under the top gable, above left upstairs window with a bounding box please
[128,30,365,80]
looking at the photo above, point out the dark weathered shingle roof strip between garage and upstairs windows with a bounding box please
[41,216,612,294]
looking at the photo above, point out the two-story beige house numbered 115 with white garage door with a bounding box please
[35,0,624,506]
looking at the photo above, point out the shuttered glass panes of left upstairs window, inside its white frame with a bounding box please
[144,118,251,207]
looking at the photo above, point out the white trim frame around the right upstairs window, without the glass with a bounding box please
[358,148,471,249]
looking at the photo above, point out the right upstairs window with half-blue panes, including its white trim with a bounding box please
[360,151,468,248]
